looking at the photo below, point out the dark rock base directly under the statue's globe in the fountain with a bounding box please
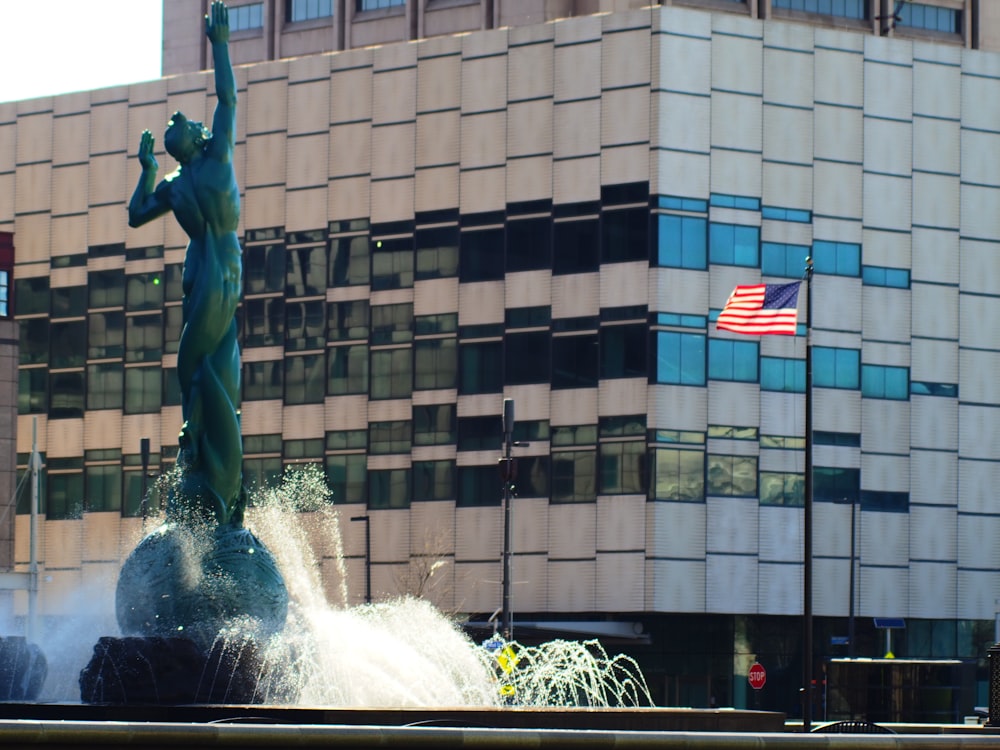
[80,636,290,706]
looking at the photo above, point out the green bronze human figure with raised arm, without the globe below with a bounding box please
[128,2,244,523]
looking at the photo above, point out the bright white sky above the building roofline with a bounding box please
[0,0,162,102]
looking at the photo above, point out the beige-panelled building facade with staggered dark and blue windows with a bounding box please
[0,4,1000,715]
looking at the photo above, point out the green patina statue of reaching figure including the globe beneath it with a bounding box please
[116,0,288,648]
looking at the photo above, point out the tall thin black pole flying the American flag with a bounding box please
[802,257,813,732]
